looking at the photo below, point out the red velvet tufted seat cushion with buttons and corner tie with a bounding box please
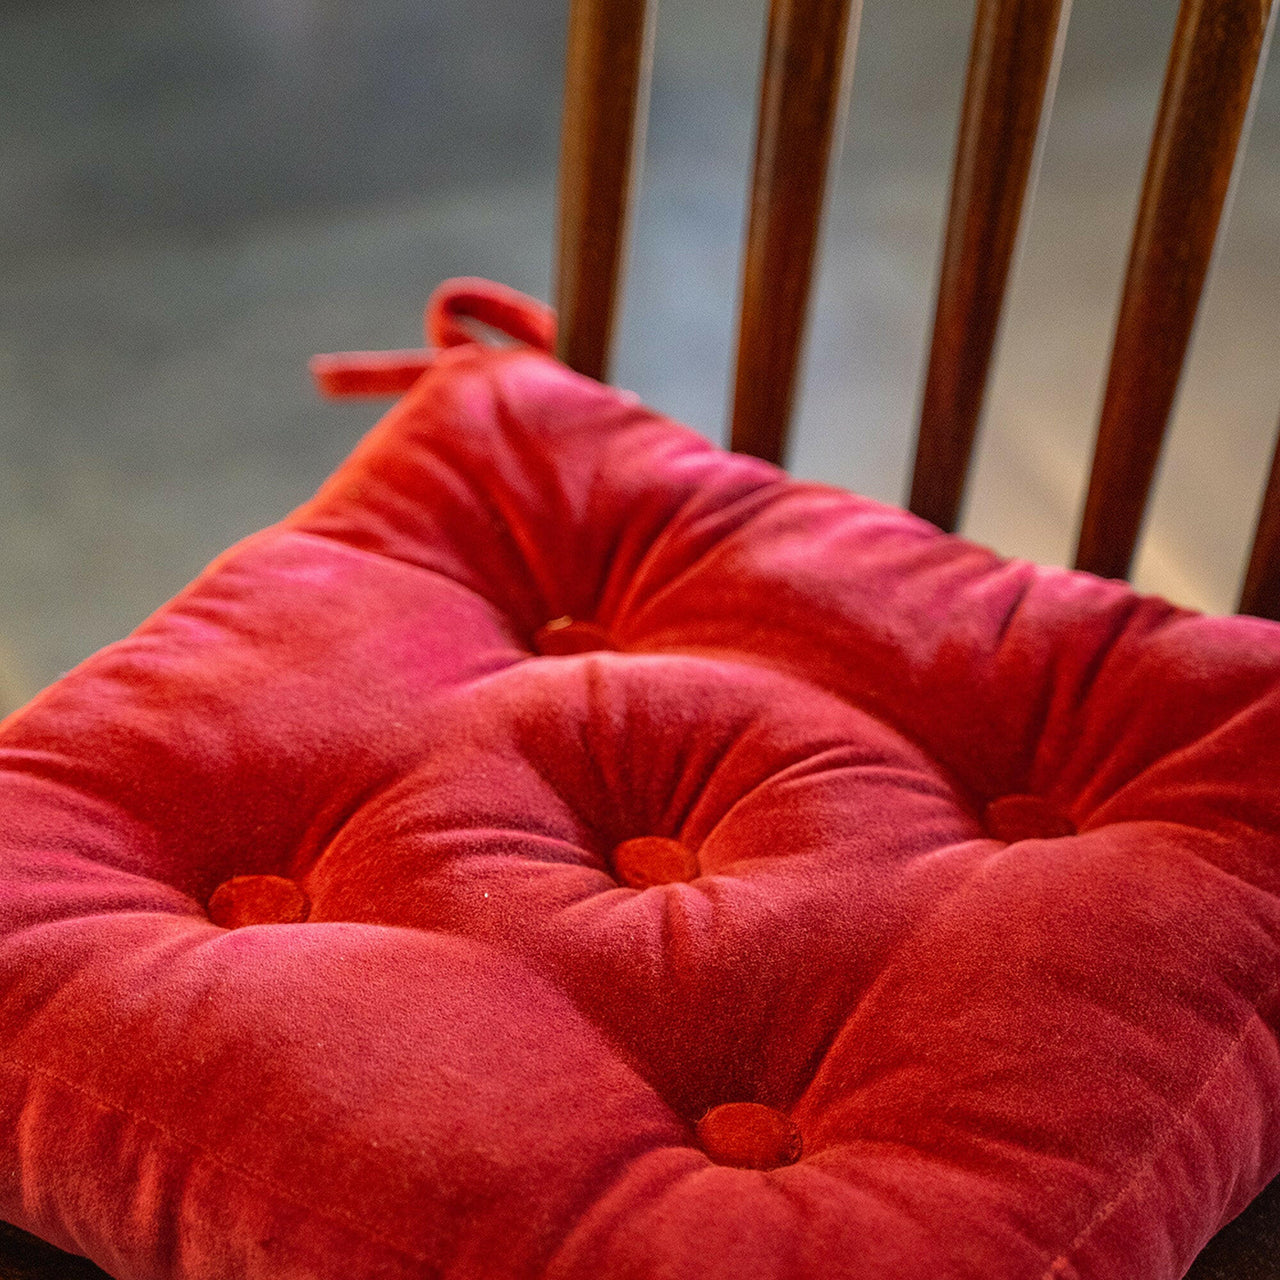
[0,285,1280,1280]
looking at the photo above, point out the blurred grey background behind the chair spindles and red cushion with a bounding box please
[0,0,1280,710]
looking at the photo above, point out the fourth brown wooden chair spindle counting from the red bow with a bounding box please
[1075,0,1271,577]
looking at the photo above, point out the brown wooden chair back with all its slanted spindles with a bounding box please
[557,0,1280,618]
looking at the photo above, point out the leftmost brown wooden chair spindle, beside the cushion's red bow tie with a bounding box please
[556,0,655,379]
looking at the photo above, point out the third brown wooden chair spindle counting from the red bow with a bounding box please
[909,0,1065,532]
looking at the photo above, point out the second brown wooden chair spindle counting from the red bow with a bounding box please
[731,0,861,462]
